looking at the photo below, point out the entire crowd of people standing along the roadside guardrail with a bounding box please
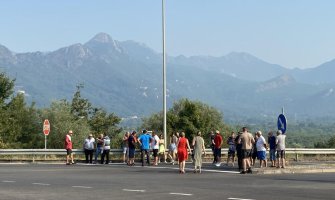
[65,127,286,174]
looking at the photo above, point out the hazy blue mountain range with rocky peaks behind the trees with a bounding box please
[0,33,335,122]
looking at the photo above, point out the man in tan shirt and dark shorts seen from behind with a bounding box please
[238,127,255,174]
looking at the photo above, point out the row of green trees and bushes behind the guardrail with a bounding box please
[0,72,335,149]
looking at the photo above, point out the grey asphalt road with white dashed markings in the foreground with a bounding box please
[0,164,335,200]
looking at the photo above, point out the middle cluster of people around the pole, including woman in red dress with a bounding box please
[123,130,205,173]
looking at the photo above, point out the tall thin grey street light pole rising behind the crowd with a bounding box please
[162,0,167,149]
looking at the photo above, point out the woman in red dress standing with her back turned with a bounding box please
[177,132,191,174]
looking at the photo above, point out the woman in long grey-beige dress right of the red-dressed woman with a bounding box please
[192,131,206,173]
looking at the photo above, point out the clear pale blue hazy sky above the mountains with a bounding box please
[0,0,335,68]
